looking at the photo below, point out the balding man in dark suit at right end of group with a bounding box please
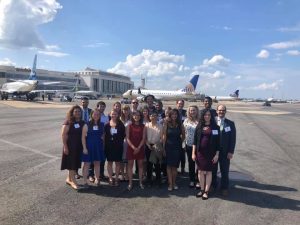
[212,105,236,196]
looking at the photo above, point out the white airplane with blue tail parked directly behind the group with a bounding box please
[122,75,199,101]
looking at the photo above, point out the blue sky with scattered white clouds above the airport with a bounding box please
[0,0,300,99]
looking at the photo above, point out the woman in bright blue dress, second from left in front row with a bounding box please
[82,109,105,186]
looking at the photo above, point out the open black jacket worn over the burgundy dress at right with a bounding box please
[193,123,220,155]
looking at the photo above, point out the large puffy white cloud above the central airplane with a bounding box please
[107,49,186,76]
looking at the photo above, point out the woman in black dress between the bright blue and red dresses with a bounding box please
[104,109,125,186]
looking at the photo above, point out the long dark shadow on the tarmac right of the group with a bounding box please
[221,180,300,211]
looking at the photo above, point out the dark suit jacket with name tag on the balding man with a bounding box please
[220,118,236,156]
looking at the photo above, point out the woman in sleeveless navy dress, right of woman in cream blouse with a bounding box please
[162,109,185,191]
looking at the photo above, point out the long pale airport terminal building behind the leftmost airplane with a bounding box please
[0,65,133,96]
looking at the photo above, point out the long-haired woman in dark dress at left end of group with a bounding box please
[61,105,84,190]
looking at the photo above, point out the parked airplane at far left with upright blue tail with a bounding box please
[0,55,59,101]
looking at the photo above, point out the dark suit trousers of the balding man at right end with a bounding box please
[212,153,230,190]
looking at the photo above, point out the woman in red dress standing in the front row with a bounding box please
[126,111,146,191]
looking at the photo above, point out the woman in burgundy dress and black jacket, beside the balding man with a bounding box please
[192,109,220,200]
